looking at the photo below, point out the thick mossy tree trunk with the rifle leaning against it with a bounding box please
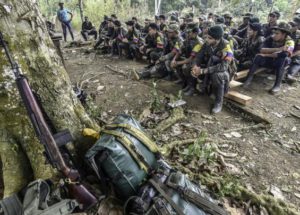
[0,0,98,196]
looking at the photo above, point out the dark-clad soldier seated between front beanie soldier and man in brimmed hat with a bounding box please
[234,23,264,71]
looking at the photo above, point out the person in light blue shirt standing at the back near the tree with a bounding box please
[57,2,74,42]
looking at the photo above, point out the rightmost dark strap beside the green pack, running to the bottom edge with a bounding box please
[166,180,228,215]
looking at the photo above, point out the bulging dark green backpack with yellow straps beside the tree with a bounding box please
[86,115,159,200]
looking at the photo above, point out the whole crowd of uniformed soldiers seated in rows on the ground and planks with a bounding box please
[75,9,300,113]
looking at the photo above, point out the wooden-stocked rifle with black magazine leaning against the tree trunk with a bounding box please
[0,32,97,210]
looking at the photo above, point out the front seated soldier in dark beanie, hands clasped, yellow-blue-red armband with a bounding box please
[192,25,233,113]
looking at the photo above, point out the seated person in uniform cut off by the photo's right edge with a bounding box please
[286,16,300,83]
